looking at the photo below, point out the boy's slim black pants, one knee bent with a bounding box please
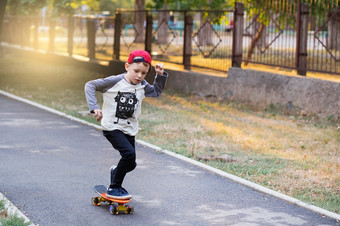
[103,130,137,188]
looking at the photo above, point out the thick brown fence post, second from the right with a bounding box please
[231,2,244,67]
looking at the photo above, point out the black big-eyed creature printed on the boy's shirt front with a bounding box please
[114,91,138,124]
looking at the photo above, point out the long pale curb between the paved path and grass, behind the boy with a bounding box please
[0,90,340,221]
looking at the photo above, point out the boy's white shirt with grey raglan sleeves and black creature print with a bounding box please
[85,72,168,136]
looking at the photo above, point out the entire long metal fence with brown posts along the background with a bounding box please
[2,0,340,75]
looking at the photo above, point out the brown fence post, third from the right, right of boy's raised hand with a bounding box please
[183,13,193,70]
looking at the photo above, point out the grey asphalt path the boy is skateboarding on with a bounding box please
[0,95,339,226]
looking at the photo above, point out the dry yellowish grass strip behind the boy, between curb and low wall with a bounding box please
[0,50,340,213]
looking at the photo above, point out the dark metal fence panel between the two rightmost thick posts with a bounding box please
[243,0,297,68]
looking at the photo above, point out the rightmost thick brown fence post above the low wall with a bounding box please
[296,2,309,75]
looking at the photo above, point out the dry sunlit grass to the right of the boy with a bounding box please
[139,93,340,212]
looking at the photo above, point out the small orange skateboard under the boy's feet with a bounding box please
[92,185,133,215]
